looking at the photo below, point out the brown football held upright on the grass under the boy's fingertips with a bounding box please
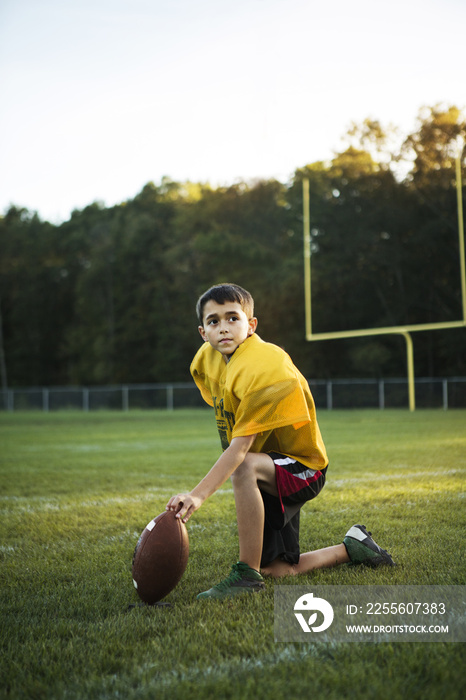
[132,510,189,605]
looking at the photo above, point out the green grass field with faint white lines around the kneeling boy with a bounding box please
[0,410,466,700]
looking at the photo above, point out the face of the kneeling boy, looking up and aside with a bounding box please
[199,299,257,362]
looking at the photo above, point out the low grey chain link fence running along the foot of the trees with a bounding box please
[0,377,466,411]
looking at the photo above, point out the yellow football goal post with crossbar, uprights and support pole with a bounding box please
[303,160,466,411]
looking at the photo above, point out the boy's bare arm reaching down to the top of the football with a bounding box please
[166,435,256,523]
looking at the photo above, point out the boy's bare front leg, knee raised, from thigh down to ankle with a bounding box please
[231,452,278,571]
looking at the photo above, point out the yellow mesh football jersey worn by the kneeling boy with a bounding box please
[191,333,328,469]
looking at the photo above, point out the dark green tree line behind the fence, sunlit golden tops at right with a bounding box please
[0,105,466,388]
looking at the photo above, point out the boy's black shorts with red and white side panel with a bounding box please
[261,452,327,566]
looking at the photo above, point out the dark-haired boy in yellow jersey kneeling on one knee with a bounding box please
[166,284,393,599]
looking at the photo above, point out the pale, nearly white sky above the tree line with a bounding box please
[0,0,466,223]
